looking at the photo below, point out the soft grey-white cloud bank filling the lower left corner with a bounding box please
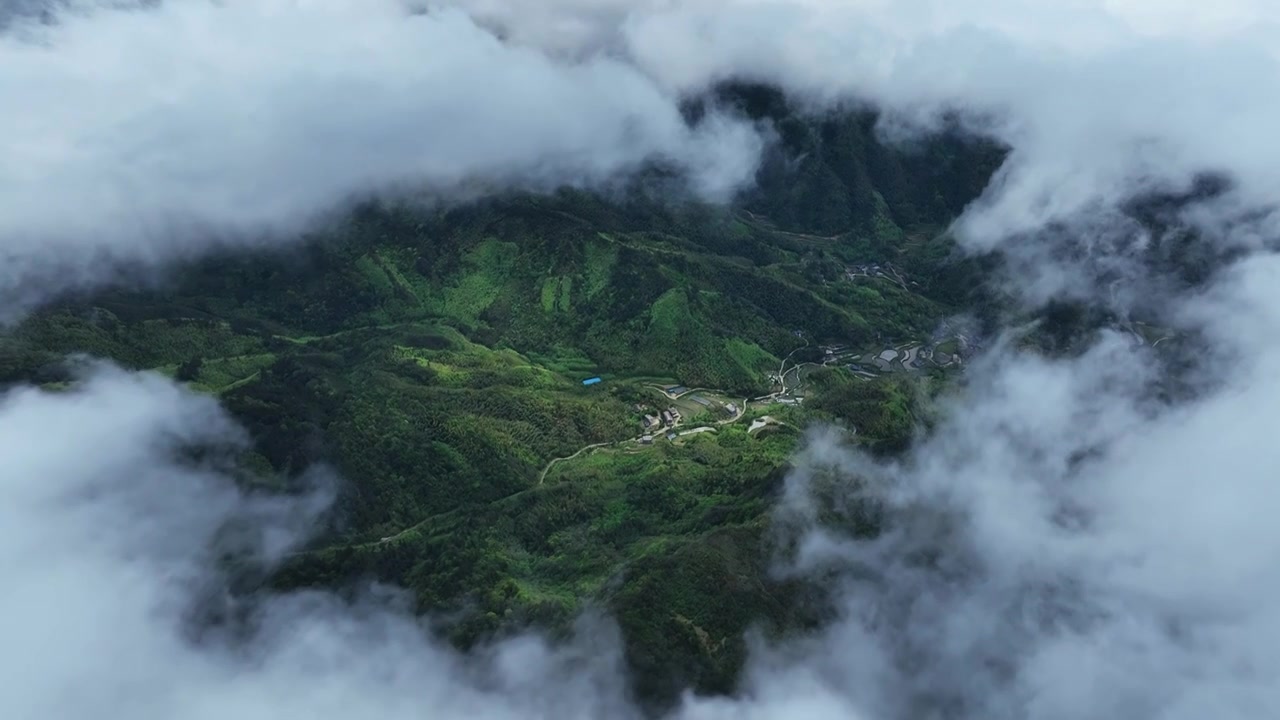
[0,368,631,720]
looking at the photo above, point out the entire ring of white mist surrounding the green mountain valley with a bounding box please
[0,0,1280,720]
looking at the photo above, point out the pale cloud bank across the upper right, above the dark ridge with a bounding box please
[447,0,1280,275]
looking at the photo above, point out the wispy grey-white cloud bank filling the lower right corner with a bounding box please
[691,256,1280,720]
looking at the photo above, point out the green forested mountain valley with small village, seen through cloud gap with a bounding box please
[0,95,1000,703]
